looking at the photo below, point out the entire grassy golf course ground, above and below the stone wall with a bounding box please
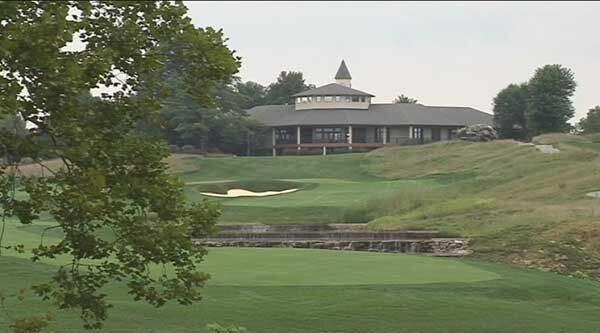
[0,136,600,333]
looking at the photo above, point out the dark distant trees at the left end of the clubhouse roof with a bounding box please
[150,70,314,155]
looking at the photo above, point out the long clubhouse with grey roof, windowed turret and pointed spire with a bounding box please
[247,60,493,156]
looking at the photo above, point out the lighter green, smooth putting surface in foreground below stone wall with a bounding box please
[206,248,500,286]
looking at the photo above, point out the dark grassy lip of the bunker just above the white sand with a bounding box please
[194,180,318,194]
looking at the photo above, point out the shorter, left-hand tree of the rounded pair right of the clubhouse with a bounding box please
[493,83,528,139]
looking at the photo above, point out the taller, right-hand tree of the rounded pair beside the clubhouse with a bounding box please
[527,64,577,135]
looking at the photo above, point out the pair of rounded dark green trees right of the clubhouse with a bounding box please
[493,64,577,140]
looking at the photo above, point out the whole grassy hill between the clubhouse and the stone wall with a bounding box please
[171,135,600,275]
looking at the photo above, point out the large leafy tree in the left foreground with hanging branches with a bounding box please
[0,1,239,328]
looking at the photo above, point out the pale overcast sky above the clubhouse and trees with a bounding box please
[187,2,600,119]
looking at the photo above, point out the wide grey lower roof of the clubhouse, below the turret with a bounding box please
[247,104,493,126]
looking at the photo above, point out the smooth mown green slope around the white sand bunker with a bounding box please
[179,154,435,223]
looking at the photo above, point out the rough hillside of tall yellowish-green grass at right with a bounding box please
[353,135,600,276]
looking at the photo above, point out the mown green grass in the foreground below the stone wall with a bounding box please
[0,245,600,333]
